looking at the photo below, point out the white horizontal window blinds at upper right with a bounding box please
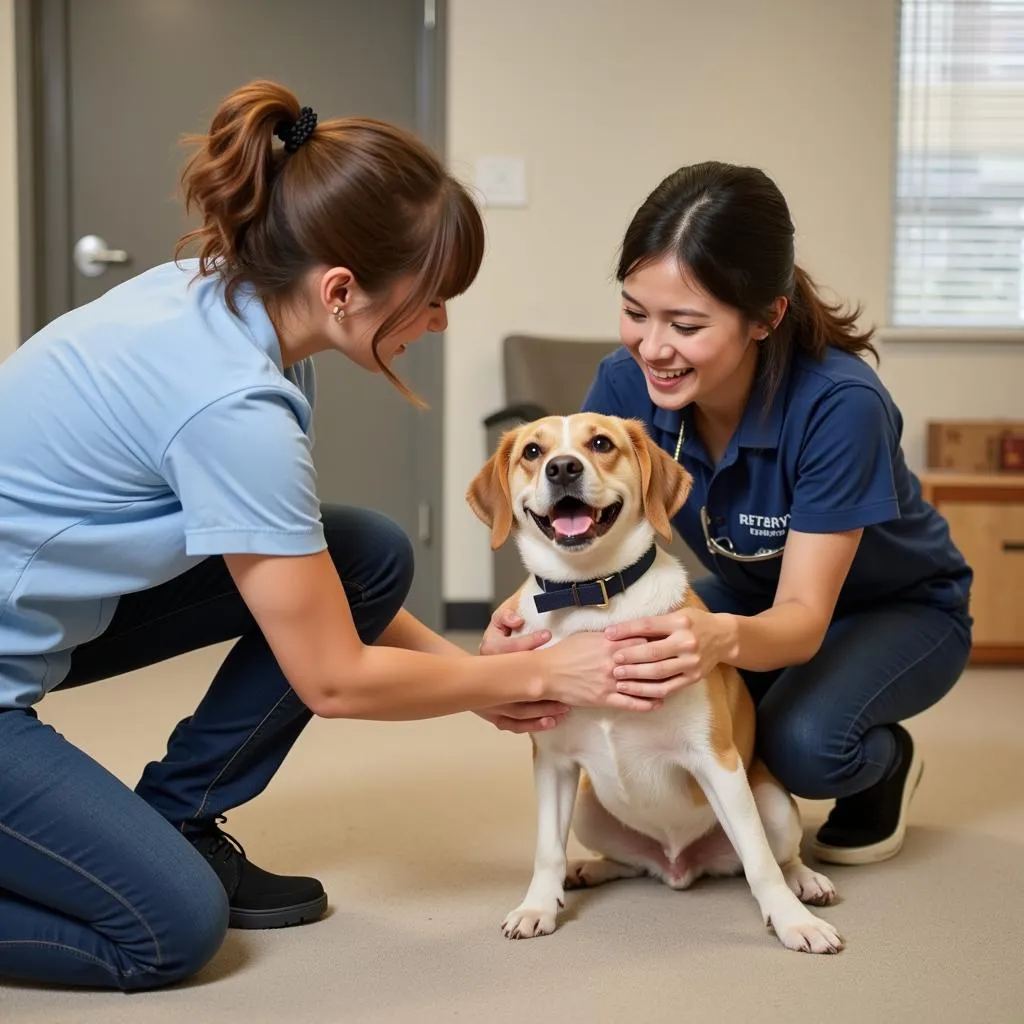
[891,0,1024,328]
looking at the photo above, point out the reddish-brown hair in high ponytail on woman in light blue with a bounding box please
[176,81,484,403]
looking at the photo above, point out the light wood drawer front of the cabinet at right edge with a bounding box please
[940,500,1024,645]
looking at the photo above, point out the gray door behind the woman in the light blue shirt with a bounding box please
[23,0,443,628]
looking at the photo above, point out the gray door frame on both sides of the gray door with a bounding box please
[14,0,447,629]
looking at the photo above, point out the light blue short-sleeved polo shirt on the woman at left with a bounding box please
[0,260,327,710]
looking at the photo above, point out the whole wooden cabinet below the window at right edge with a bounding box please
[921,471,1024,664]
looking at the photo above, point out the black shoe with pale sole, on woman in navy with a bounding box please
[812,725,925,864]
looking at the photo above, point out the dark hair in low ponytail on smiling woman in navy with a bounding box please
[616,162,878,409]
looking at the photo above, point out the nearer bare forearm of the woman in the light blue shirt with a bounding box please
[312,647,544,722]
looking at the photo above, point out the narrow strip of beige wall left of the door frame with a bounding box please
[0,0,18,359]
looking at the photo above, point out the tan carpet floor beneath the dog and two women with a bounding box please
[0,648,1024,1024]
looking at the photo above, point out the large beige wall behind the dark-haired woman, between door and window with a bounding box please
[444,0,1024,600]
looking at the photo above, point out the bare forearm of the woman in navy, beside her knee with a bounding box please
[723,601,827,672]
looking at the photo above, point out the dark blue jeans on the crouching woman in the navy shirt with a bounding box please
[693,575,971,800]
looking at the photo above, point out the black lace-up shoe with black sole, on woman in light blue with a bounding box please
[187,817,327,928]
